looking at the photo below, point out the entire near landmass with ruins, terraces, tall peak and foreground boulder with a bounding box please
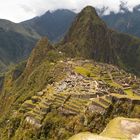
[0,6,140,140]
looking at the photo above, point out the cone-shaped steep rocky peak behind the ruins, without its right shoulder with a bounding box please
[62,7,115,62]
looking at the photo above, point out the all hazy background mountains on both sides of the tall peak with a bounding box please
[0,6,140,71]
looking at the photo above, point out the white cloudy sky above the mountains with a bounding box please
[0,0,140,22]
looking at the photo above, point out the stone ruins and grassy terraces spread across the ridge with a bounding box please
[19,60,140,128]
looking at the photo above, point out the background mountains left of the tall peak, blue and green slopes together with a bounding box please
[0,10,76,71]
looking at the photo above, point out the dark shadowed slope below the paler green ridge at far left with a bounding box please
[0,28,36,71]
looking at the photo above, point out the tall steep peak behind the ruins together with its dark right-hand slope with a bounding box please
[61,6,140,74]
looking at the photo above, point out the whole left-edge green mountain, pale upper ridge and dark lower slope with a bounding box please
[0,19,40,72]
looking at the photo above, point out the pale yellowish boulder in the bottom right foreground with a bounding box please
[69,117,140,140]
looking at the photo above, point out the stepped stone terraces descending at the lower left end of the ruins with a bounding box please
[20,93,55,128]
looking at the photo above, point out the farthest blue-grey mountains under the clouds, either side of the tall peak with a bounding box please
[20,5,140,41]
